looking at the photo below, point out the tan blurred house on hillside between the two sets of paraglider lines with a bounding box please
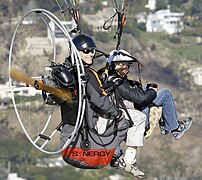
[82,7,118,32]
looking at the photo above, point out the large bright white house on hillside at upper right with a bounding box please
[146,9,184,34]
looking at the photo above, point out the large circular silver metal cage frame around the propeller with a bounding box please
[9,9,86,154]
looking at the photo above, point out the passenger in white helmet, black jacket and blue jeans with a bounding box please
[104,50,192,179]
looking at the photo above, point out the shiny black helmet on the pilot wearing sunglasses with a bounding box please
[72,34,96,50]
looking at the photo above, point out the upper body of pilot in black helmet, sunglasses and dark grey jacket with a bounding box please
[73,34,119,119]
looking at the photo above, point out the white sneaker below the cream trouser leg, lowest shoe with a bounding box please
[119,156,146,179]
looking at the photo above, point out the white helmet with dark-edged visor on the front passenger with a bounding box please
[106,49,134,64]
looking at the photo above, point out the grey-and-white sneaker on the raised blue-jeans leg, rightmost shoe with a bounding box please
[171,117,192,140]
